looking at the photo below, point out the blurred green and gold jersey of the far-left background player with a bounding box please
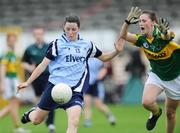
[1,50,18,77]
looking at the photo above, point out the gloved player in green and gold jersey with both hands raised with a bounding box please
[120,7,180,133]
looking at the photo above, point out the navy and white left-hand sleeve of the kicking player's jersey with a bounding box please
[46,40,58,61]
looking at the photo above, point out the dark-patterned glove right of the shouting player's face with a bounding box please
[158,18,169,35]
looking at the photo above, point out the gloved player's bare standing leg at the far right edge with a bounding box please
[166,98,179,133]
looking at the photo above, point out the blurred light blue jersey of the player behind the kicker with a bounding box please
[88,58,103,85]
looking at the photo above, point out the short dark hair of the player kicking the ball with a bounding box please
[64,15,80,28]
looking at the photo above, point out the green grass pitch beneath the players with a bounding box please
[0,105,180,133]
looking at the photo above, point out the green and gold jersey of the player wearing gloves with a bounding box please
[133,27,180,81]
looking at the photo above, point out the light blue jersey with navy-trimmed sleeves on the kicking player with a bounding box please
[46,34,102,92]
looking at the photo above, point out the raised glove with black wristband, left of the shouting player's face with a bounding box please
[125,7,142,24]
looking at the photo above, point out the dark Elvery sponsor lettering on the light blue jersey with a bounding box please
[66,54,86,64]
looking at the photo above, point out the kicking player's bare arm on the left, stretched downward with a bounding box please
[18,57,50,90]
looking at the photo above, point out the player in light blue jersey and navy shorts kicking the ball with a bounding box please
[18,15,124,133]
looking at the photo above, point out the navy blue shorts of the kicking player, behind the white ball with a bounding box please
[38,82,83,111]
